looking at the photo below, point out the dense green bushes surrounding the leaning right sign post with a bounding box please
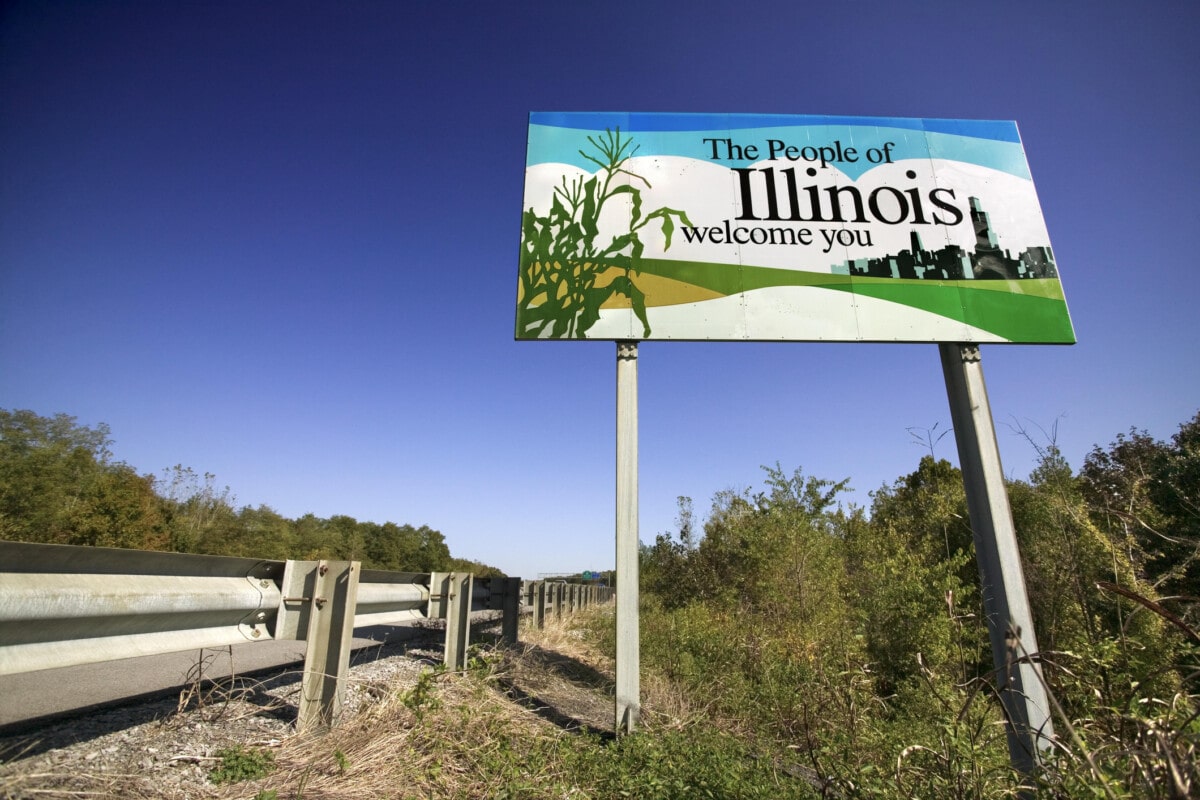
[642,447,1200,798]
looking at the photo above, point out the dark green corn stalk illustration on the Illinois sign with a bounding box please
[517,128,691,338]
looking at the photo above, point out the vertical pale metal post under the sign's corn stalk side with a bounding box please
[616,342,642,734]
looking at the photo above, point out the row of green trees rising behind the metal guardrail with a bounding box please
[0,409,503,577]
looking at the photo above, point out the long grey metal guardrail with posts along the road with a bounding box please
[0,541,612,729]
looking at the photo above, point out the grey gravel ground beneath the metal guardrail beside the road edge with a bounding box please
[0,640,451,800]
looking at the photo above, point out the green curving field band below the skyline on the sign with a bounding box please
[640,259,1075,344]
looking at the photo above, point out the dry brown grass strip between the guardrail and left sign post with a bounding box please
[213,608,628,800]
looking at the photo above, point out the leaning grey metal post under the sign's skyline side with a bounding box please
[938,343,1054,775]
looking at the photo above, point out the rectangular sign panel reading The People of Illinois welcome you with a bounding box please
[516,113,1075,343]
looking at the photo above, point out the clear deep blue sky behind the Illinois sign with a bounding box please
[0,0,1200,577]
